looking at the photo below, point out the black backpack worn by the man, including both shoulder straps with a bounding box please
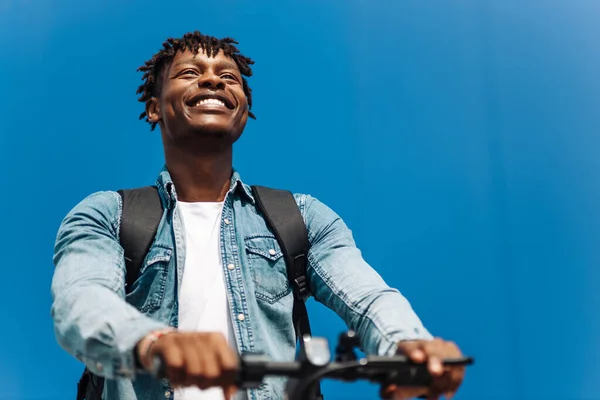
[77,186,321,400]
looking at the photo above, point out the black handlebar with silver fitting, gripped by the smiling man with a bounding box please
[154,331,474,400]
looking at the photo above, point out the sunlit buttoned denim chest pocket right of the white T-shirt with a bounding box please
[245,236,291,304]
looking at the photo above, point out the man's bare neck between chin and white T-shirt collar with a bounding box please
[165,148,233,203]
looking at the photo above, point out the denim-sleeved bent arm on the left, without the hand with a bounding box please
[52,192,166,378]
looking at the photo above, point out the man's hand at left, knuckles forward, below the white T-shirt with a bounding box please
[137,332,239,398]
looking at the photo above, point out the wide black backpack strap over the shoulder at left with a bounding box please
[118,186,163,289]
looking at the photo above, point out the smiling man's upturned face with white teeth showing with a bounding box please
[148,50,248,143]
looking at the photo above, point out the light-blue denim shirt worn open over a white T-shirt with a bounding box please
[52,168,431,400]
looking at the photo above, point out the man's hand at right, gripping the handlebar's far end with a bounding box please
[381,338,465,400]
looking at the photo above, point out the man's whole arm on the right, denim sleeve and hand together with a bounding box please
[300,196,465,400]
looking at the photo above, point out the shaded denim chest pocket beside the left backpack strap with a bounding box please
[127,246,172,313]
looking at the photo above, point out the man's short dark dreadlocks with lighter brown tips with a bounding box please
[137,31,256,130]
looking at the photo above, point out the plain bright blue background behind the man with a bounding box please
[0,0,600,400]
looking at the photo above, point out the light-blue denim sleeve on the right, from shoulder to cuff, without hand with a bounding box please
[301,196,432,355]
